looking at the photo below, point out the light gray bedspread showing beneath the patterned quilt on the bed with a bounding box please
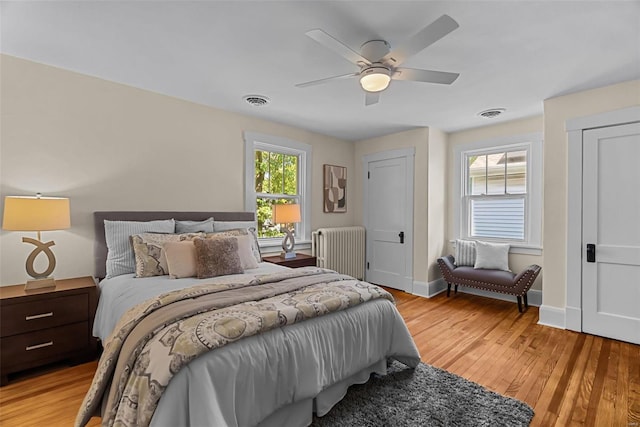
[94,263,420,427]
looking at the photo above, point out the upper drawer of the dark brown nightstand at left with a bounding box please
[0,294,89,338]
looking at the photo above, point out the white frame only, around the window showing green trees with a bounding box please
[244,132,312,249]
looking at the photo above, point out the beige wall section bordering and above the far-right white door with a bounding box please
[542,80,640,309]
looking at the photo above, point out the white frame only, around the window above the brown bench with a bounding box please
[453,132,543,255]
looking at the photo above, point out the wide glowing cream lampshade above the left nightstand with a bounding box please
[2,196,71,231]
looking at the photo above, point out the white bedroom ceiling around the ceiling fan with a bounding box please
[0,0,640,140]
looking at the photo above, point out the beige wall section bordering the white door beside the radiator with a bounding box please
[349,128,429,281]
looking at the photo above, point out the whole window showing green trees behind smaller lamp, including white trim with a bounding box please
[245,133,311,246]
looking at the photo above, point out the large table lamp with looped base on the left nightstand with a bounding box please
[2,193,71,290]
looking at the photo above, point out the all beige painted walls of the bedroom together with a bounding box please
[0,55,640,308]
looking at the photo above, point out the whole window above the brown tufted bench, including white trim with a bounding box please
[455,134,542,254]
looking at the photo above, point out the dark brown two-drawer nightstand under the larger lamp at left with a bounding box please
[0,276,98,385]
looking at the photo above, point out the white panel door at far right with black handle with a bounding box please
[582,123,640,344]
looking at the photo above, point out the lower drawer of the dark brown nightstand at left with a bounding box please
[0,321,89,370]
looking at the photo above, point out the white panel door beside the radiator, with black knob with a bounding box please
[365,157,413,291]
